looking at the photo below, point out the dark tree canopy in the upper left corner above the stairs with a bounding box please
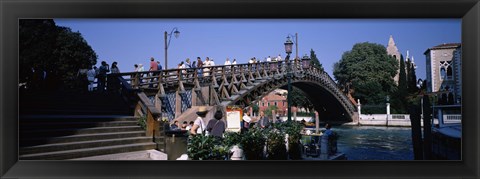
[19,19,97,89]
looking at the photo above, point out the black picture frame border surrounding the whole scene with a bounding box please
[0,0,480,178]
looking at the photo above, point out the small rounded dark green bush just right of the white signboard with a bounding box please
[240,128,266,160]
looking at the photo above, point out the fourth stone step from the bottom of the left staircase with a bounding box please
[19,126,143,138]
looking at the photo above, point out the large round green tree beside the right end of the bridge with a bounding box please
[333,42,398,104]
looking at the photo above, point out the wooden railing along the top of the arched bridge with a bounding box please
[107,61,356,120]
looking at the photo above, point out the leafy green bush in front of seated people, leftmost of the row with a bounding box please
[187,135,230,160]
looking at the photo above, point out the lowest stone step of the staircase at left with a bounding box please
[19,142,156,160]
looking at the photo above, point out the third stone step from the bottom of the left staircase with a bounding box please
[19,131,145,147]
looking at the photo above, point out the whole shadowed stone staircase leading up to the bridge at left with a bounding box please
[19,92,159,160]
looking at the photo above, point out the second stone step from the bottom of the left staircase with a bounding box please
[20,137,159,155]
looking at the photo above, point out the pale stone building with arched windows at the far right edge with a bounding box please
[424,43,462,104]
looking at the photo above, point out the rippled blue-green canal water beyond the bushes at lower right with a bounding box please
[332,126,413,160]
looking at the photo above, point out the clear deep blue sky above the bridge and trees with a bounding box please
[55,19,461,78]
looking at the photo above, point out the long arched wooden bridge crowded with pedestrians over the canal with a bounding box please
[107,61,356,125]
